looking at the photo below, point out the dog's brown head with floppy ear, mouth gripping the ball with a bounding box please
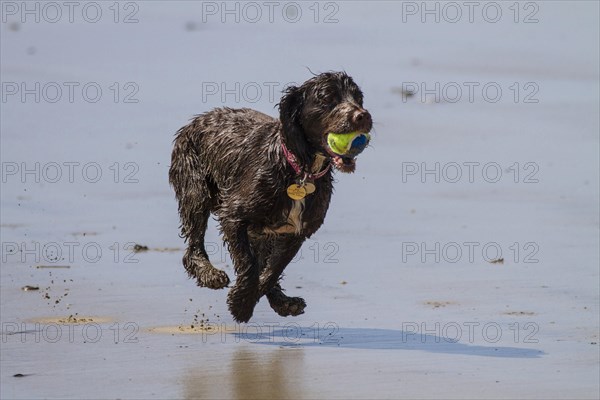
[279,72,373,172]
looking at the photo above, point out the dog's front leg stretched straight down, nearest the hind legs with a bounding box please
[222,224,260,322]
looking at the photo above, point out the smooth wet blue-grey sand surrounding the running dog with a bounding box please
[0,2,600,399]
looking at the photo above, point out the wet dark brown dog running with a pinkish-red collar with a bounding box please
[169,72,372,322]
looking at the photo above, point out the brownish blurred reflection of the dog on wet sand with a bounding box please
[182,346,306,399]
